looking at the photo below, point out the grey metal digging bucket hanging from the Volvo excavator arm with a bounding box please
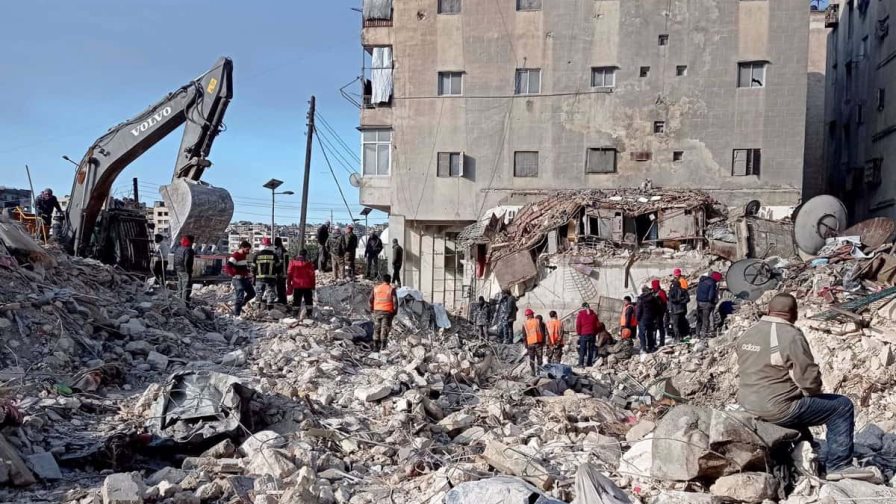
[159,178,233,244]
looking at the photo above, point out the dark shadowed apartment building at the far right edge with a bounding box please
[825,0,896,221]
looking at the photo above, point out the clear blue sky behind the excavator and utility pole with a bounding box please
[0,0,386,223]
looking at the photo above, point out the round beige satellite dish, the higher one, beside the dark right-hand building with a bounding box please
[793,195,847,255]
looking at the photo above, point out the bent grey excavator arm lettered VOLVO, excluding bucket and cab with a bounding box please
[63,58,233,255]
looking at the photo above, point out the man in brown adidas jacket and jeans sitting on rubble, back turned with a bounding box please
[737,294,871,481]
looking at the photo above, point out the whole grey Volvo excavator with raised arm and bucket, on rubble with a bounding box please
[61,58,233,271]
